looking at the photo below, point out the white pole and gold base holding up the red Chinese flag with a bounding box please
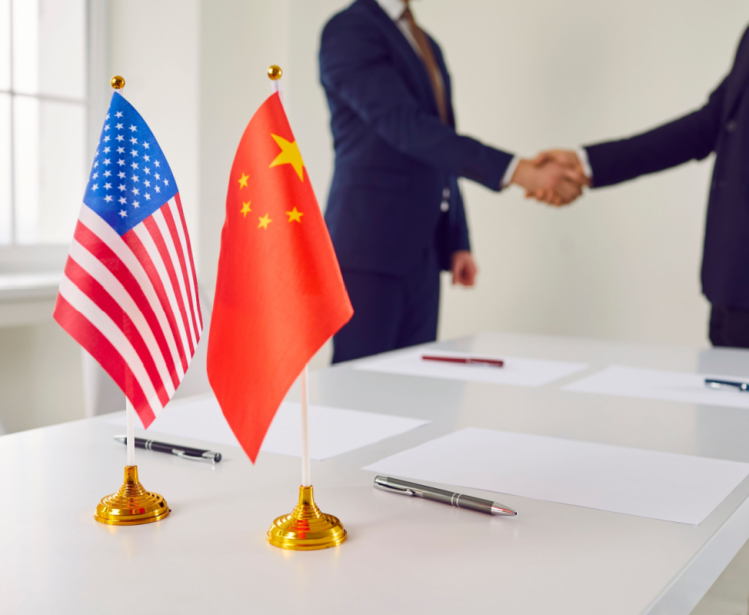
[268,364,346,551]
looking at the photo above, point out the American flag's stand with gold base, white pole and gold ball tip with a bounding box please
[94,75,172,525]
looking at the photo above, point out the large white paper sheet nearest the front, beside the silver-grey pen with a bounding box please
[364,427,749,525]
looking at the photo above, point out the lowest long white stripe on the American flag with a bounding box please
[60,276,162,414]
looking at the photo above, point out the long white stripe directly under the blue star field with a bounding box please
[79,205,189,381]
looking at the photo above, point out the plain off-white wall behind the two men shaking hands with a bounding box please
[276,0,749,345]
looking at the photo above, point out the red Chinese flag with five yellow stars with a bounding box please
[208,94,353,463]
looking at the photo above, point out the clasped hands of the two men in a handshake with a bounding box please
[512,156,582,207]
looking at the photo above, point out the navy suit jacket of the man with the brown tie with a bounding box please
[320,0,512,274]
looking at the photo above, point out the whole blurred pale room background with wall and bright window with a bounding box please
[0,0,749,432]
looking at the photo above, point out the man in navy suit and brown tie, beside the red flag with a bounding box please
[320,0,580,363]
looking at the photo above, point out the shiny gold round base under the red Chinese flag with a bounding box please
[268,486,346,551]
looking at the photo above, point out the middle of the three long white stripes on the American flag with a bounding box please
[69,239,175,399]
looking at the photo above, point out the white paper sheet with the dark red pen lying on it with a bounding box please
[355,348,588,387]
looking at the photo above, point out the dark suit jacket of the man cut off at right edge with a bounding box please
[586,29,749,309]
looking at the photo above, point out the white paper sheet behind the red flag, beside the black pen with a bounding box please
[108,397,430,461]
